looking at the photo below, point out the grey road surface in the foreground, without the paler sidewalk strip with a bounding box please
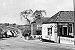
[0,38,72,50]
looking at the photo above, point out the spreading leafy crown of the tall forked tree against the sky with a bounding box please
[21,9,46,24]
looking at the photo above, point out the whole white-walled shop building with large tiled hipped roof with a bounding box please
[42,11,74,44]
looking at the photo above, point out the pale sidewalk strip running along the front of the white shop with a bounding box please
[24,40,75,50]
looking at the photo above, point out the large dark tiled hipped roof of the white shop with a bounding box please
[44,11,74,23]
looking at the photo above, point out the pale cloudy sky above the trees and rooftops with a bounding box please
[0,0,73,24]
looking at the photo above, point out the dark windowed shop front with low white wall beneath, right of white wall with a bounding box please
[58,23,74,44]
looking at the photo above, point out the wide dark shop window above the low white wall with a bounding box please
[59,24,74,38]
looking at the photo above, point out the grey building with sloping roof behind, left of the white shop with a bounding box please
[31,17,49,35]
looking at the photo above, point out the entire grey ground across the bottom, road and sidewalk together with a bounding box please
[0,37,75,50]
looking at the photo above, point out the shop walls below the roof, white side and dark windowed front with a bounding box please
[42,22,74,44]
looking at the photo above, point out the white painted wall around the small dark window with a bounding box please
[42,23,57,41]
